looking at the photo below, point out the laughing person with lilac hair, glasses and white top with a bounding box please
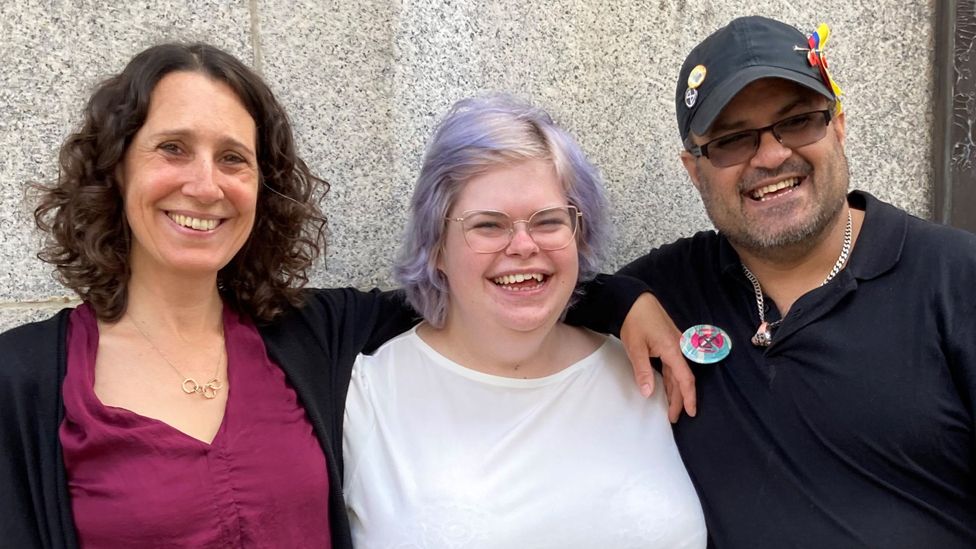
[344,96,705,548]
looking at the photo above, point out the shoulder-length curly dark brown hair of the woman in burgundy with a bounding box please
[34,43,328,321]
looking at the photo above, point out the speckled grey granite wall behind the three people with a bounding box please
[0,0,935,330]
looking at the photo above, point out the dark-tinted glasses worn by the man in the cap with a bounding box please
[688,109,830,168]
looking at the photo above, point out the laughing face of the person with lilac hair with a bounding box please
[437,160,585,333]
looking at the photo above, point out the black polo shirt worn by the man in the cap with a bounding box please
[620,192,976,548]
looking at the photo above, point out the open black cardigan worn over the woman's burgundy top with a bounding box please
[0,276,646,549]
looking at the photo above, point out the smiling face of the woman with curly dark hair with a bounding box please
[120,72,259,277]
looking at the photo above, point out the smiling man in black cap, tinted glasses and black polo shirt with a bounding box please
[621,17,976,548]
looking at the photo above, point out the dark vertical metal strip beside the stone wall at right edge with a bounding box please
[932,0,976,232]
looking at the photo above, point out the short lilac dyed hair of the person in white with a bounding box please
[393,95,609,327]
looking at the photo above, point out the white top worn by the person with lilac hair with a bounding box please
[343,329,706,549]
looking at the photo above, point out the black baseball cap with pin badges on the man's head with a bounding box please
[674,16,835,142]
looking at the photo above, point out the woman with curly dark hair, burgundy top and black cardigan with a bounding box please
[0,39,692,547]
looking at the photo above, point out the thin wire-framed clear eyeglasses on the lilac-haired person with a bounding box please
[445,206,583,254]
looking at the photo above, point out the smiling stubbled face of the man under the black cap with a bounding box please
[681,79,849,254]
